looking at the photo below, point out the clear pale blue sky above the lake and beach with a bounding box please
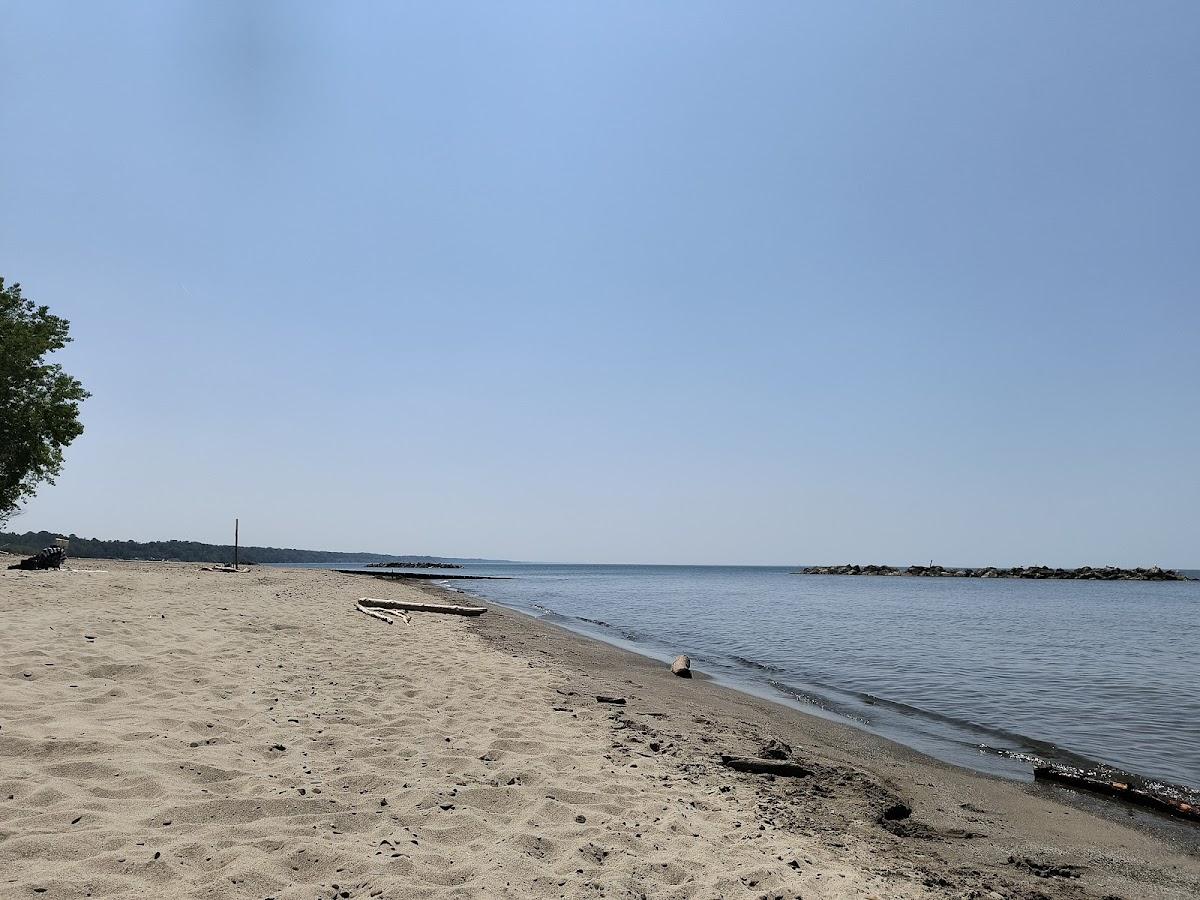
[0,0,1200,566]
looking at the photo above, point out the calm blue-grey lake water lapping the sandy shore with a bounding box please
[417,565,1200,790]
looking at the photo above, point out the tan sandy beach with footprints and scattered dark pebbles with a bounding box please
[0,560,1200,900]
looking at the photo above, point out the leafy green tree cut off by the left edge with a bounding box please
[0,278,91,523]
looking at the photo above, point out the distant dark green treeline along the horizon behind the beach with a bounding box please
[0,532,472,563]
